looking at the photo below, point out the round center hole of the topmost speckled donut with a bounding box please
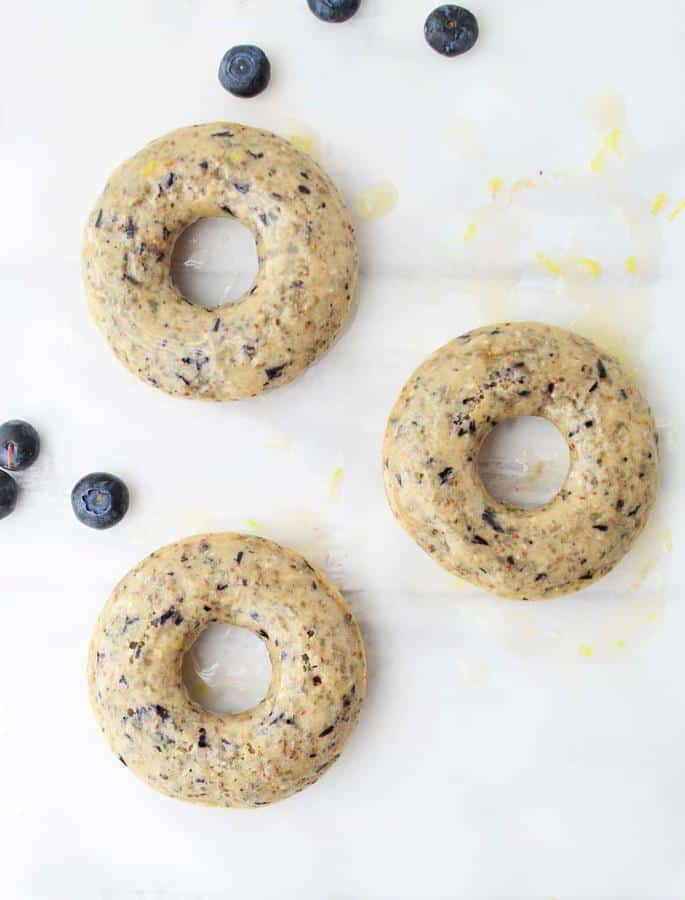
[171,217,259,309]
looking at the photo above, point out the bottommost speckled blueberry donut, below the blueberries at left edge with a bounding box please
[88,534,366,807]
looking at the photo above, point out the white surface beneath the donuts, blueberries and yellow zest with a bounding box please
[0,0,685,900]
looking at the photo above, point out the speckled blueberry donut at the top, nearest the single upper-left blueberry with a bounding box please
[82,122,357,401]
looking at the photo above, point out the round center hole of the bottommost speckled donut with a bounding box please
[182,623,272,715]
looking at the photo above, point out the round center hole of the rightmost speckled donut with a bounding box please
[478,416,571,509]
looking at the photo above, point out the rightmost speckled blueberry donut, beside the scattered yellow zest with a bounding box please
[383,322,658,600]
